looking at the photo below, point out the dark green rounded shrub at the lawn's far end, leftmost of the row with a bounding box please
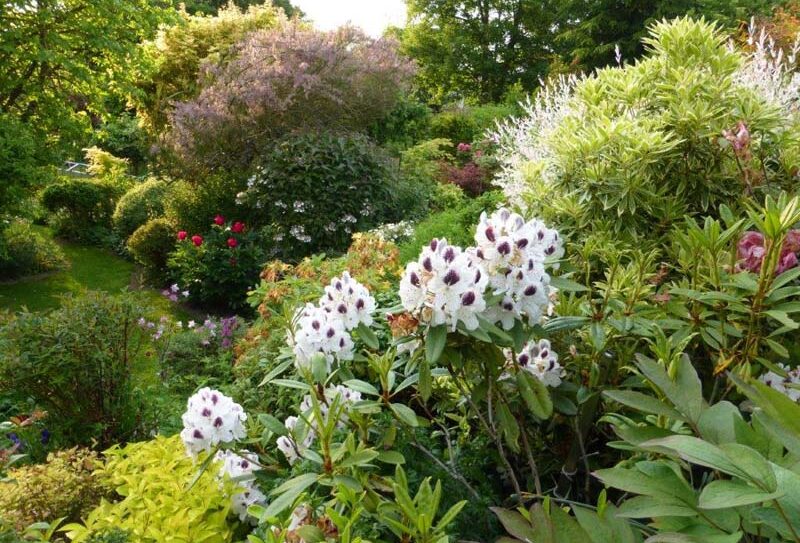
[41,178,119,243]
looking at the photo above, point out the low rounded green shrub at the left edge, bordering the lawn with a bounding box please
[0,219,67,280]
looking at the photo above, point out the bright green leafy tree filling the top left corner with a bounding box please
[0,0,173,153]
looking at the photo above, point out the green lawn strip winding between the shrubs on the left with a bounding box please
[0,228,191,319]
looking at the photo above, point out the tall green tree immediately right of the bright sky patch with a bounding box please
[402,0,558,101]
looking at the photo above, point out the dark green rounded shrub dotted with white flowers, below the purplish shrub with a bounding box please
[243,132,399,260]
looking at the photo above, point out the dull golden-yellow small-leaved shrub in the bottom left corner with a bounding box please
[0,448,107,530]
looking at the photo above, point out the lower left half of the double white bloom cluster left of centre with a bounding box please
[288,304,353,370]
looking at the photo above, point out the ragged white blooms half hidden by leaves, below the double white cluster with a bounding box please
[277,385,361,464]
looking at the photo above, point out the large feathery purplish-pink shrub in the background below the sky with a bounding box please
[167,23,413,174]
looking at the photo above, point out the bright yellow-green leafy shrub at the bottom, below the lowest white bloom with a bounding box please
[65,436,234,543]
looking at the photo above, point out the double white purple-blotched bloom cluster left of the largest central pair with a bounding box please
[287,272,377,370]
